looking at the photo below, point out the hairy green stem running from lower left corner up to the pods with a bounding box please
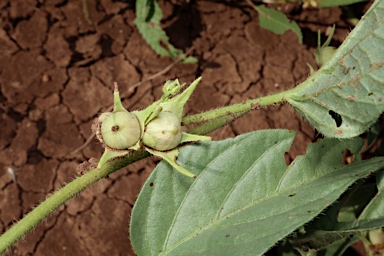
[0,150,149,254]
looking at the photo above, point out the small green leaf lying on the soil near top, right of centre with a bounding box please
[254,5,303,44]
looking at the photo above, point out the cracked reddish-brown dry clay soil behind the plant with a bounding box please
[0,0,367,256]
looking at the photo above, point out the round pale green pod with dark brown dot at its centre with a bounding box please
[101,111,141,149]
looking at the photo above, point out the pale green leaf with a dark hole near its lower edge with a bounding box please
[287,0,384,138]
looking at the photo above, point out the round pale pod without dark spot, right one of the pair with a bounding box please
[142,111,182,151]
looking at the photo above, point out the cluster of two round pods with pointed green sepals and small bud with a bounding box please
[92,77,211,177]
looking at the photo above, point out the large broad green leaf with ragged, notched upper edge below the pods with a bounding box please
[130,130,384,256]
